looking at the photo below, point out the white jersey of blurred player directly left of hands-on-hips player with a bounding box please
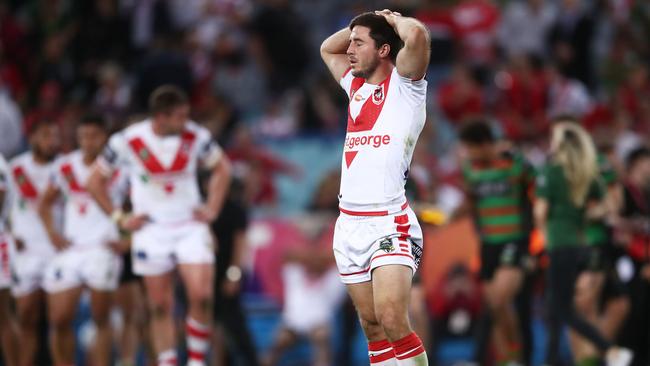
[52,150,125,247]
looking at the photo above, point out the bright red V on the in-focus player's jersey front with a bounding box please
[344,73,392,168]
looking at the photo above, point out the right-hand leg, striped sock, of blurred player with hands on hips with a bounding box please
[179,263,214,366]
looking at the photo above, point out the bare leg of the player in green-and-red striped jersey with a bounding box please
[486,267,523,361]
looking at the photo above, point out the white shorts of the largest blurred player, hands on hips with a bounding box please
[131,222,215,276]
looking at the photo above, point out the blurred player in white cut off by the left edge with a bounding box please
[0,154,18,366]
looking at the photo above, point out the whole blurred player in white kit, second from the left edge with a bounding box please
[9,121,61,365]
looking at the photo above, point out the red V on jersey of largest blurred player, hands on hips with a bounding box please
[129,131,196,174]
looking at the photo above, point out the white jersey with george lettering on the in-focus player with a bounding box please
[339,68,427,214]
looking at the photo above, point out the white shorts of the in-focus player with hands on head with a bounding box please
[334,207,423,284]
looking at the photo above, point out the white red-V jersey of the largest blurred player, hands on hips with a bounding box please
[98,120,223,223]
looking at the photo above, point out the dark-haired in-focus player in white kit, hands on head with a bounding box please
[321,10,430,365]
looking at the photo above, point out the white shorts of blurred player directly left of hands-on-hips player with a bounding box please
[43,246,122,293]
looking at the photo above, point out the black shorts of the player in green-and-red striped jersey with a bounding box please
[479,240,527,281]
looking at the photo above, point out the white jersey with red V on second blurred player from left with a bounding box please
[9,152,61,255]
